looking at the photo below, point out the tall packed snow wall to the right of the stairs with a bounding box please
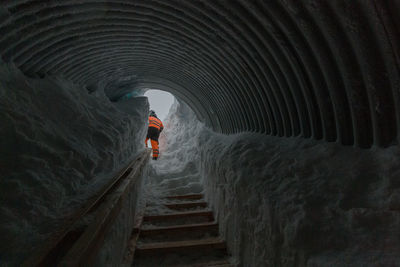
[167,100,400,266]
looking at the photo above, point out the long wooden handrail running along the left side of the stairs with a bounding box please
[22,149,151,267]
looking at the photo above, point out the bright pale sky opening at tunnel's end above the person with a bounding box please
[144,89,174,120]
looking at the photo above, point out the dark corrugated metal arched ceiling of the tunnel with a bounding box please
[0,0,400,147]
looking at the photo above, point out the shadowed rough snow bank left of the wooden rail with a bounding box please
[0,62,148,265]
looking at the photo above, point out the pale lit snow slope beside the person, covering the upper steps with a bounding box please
[146,100,204,217]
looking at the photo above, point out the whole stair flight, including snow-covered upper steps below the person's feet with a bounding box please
[131,141,234,267]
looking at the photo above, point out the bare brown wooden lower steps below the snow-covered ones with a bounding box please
[133,194,233,267]
